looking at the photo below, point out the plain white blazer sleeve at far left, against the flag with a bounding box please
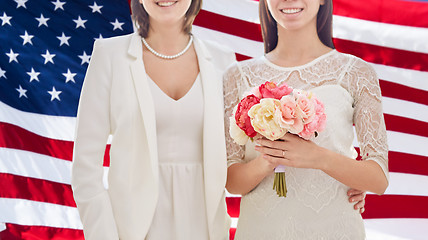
[71,40,119,240]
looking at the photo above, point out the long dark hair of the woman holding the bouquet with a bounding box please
[259,0,334,53]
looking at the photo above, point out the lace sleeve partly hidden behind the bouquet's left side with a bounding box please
[223,63,245,167]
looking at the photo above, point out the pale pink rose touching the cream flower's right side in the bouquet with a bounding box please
[275,95,303,134]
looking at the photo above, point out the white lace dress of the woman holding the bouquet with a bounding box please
[224,50,388,240]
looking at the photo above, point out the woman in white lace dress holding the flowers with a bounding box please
[224,0,389,240]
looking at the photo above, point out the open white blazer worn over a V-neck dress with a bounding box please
[71,33,235,240]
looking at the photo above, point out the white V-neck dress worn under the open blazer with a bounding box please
[146,75,209,240]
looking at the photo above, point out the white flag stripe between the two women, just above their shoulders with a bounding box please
[192,26,263,57]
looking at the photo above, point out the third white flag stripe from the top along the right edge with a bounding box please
[382,97,428,123]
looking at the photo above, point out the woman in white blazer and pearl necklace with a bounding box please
[72,0,235,240]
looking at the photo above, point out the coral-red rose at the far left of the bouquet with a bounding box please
[235,94,260,137]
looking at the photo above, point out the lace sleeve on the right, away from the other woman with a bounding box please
[347,59,389,180]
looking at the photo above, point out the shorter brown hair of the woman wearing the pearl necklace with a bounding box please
[131,0,202,38]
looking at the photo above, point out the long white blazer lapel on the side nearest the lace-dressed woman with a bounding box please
[195,39,227,236]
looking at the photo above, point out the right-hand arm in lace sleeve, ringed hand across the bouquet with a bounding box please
[257,60,388,194]
